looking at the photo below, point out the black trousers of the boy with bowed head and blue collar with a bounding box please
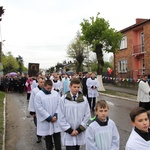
[45,132,61,150]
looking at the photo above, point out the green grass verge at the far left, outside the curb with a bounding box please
[0,92,5,150]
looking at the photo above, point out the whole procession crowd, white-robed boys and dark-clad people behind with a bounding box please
[0,72,150,150]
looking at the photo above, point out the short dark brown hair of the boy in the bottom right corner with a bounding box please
[129,107,147,122]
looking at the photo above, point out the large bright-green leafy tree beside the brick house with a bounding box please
[80,13,122,75]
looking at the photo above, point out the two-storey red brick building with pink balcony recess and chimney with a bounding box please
[114,18,150,80]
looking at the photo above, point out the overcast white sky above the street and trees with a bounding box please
[0,0,150,69]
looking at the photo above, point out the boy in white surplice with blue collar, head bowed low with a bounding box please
[34,80,61,150]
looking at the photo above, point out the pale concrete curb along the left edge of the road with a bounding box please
[2,94,6,150]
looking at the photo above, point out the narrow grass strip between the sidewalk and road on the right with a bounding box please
[100,90,137,99]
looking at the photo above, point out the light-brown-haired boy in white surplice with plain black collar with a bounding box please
[86,100,120,150]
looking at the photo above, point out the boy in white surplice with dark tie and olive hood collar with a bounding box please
[58,78,91,150]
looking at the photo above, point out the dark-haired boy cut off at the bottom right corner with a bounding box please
[126,107,150,150]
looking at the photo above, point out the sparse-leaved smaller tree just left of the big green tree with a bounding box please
[67,31,88,72]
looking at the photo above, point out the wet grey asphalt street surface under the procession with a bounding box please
[6,93,138,150]
